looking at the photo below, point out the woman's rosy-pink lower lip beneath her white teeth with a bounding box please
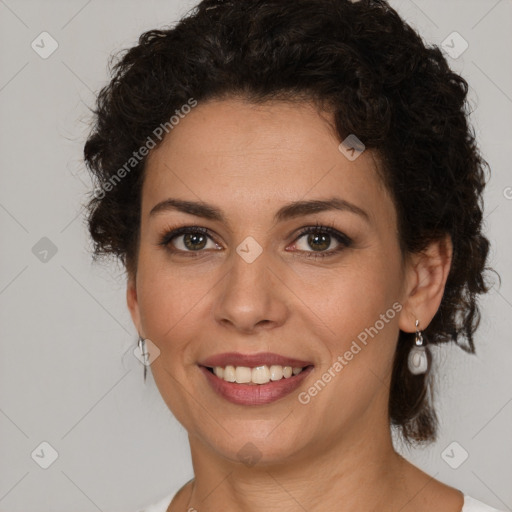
[199,366,313,405]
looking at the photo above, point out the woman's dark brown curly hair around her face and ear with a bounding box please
[84,0,489,444]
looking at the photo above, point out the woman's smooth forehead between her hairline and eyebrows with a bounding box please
[143,99,389,228]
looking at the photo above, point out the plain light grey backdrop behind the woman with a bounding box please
[0,0,512,512]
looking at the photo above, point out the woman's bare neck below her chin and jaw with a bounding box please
[186,412,410,512]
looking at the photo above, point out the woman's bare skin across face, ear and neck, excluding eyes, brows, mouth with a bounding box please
[127,98,462,512]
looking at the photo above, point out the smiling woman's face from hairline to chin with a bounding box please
[128,99,414,463]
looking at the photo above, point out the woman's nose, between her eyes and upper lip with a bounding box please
[214,242,290,334]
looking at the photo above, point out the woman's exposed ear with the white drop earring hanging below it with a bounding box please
[398,235,453,332]
